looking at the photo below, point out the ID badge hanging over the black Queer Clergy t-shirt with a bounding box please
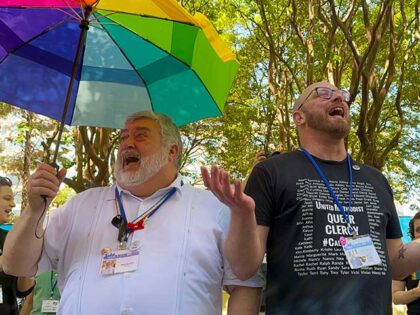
[340,235,381,269]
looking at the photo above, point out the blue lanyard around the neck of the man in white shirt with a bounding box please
[115,187,176,241]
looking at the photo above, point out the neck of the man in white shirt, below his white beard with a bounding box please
[118,169,178,199]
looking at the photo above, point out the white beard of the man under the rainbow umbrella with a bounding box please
[114,148,168,186]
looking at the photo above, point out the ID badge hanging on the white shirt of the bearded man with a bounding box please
[100,249,139,275]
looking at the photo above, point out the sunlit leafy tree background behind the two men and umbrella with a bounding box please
[0,0,420,314]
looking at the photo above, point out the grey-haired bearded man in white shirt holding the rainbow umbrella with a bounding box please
[4,112,262,315]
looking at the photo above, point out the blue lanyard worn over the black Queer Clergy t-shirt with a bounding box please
[301,148,354,236]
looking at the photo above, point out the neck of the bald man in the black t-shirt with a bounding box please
[301,136,347,161]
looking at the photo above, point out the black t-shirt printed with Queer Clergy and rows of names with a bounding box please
[245,151,402,315]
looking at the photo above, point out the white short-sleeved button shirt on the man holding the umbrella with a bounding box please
[39,176,263,315]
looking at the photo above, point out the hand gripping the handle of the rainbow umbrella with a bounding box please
[27,163,66,211]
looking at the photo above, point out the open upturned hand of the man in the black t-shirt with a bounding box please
[201,165,255,214]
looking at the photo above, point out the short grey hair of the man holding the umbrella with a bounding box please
[125,111,182,170]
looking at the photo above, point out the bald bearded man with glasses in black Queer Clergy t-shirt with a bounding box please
[202,81,420,315]
